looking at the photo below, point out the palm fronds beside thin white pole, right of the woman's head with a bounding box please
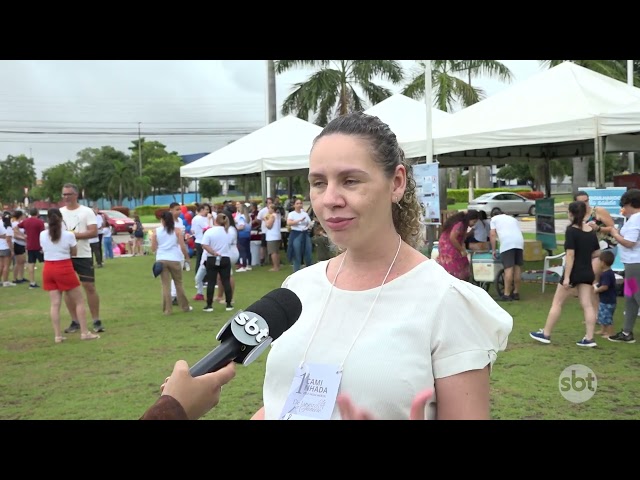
[402,60,513,112]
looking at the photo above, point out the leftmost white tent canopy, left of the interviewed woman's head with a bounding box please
[180,116,322,178]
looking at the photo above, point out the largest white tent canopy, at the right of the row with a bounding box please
[425,62,640,166]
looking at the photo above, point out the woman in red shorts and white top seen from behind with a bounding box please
[40,208,100,343]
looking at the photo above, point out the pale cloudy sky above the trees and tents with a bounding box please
[0,60,541,176]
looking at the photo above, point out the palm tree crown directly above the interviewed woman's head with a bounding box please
[275,60,404,127]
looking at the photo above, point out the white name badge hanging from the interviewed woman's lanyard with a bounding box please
[280,363,342,420]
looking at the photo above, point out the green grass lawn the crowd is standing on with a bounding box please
[0,248,640,419]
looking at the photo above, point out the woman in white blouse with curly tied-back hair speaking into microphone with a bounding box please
[253,112,513,419]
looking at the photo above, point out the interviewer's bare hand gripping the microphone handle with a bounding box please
[160,360,236,420]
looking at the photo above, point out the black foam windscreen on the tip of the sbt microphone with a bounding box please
[245,288,302,340]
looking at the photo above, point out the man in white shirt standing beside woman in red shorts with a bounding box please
[60,183,104,333]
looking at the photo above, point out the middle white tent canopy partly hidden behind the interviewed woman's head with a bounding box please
[364,93,451,158]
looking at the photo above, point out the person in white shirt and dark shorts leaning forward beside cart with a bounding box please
[489,213,524,302]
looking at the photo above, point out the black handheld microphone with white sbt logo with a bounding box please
[189,288,302,377]
